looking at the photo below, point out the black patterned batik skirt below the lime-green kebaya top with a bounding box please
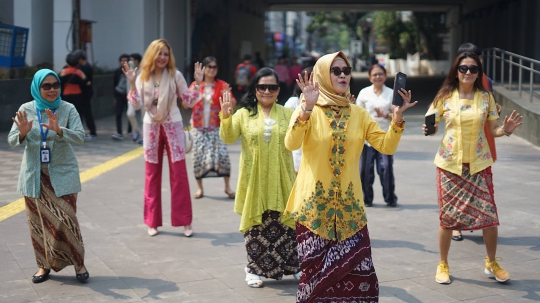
[244,211,300,280]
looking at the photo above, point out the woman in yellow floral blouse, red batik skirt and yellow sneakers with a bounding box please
[423,52,523,284]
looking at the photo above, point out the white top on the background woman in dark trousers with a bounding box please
[356,85,394,131]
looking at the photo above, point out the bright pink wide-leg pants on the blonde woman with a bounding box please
[144,126,192,228]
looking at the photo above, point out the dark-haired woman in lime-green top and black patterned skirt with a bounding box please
[219,67,300,287]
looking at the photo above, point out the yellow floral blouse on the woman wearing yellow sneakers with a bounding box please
[426,90,499,175]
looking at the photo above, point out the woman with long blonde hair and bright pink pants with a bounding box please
[123,39,203,237]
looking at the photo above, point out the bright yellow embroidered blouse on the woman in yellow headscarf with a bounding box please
[284,105,403,241]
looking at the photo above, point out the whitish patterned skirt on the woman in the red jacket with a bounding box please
[191,128,231,179]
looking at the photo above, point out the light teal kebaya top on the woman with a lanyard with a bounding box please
[8,101,84,198]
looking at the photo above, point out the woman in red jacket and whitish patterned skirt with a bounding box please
[190,57,236,199]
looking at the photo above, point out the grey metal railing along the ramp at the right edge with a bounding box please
[482,47,540,103]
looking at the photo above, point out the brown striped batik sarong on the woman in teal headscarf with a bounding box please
[24,165,84,271]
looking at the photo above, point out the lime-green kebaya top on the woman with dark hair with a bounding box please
[219,104,296,232]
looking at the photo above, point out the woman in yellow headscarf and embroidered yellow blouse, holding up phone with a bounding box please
[285,52,416,302]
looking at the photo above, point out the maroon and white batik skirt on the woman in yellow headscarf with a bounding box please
[296,223,379,303]
